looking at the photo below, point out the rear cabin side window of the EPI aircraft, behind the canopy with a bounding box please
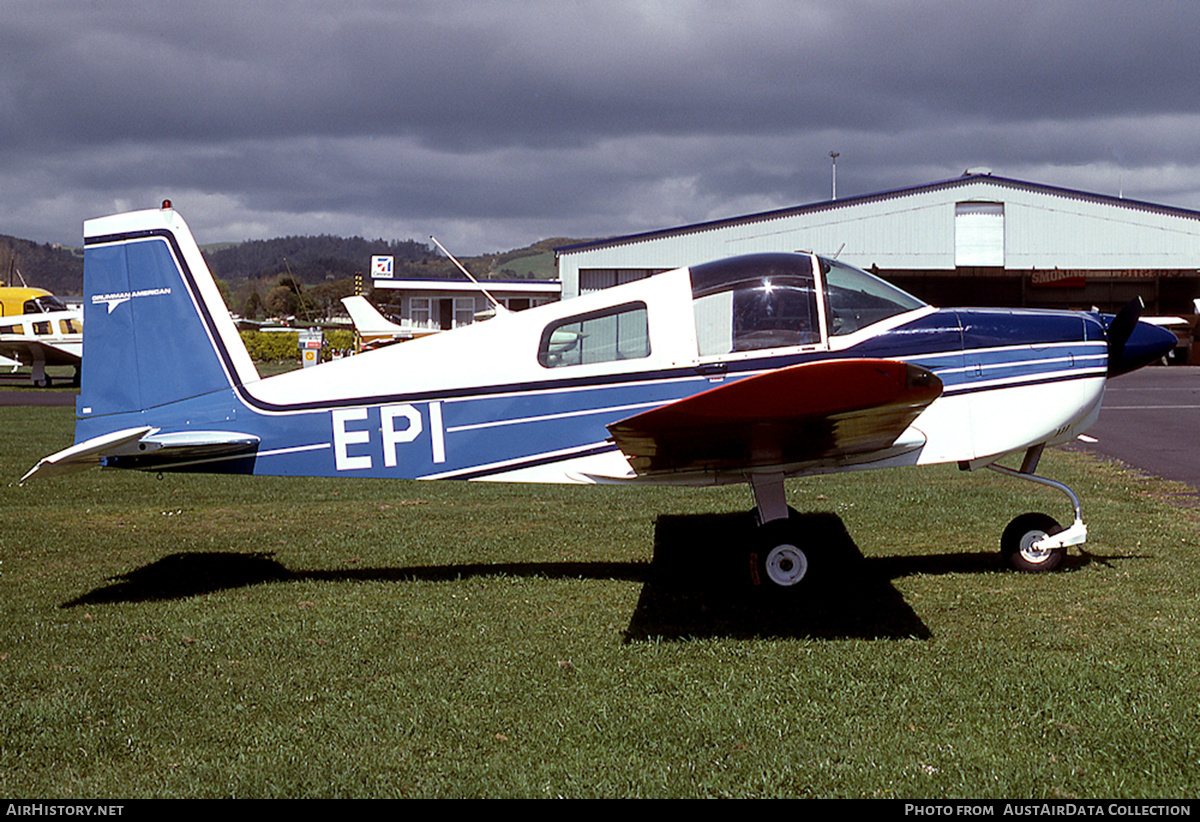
[538,302,650,368]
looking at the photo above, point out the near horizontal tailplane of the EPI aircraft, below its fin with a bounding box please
[20,426,259,482]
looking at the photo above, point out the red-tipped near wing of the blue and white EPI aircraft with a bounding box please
[608,359,942,474]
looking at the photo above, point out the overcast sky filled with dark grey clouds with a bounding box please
[0,0,1200,254]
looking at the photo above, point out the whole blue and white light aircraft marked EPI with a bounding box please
[24,203,1175,589]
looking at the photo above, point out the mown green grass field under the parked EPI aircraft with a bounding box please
[0,408,1200,798]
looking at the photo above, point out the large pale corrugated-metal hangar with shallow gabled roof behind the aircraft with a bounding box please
[556,169,1200,313]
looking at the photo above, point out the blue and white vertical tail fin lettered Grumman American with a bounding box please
[77,203,258,421]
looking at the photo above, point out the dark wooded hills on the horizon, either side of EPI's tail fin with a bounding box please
[0,228,590,296]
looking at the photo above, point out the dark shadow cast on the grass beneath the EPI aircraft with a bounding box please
[62,512,1096,641]
